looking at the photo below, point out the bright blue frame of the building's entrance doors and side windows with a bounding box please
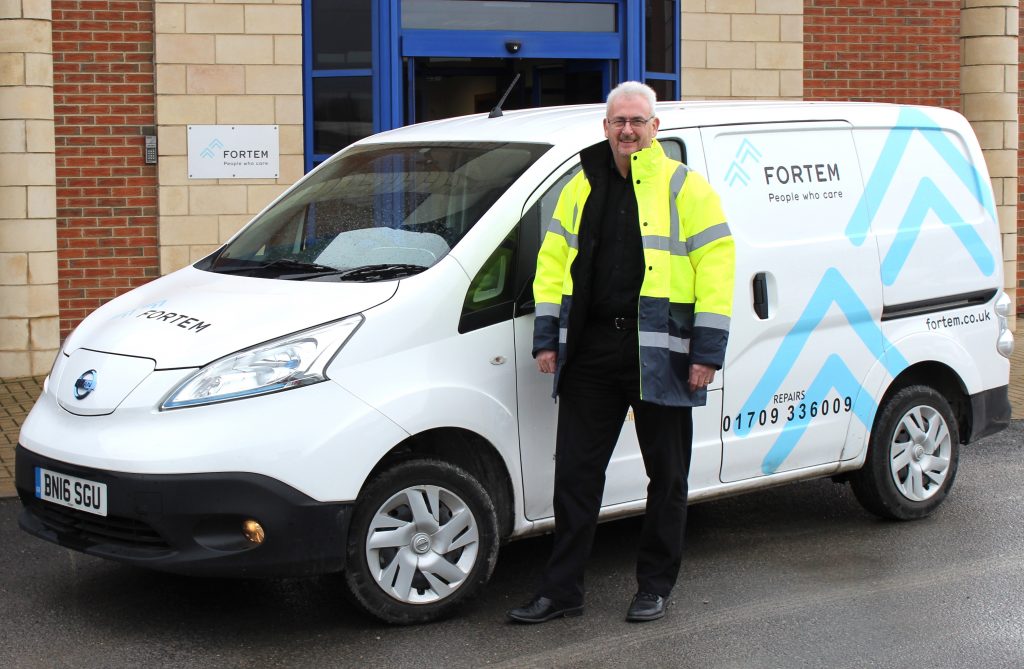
[303,0,679,170]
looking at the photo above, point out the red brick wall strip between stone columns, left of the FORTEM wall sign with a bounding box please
[52,0,159,337]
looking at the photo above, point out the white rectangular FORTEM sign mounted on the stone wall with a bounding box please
[188,125,281,179]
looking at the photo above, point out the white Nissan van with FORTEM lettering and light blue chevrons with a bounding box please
[16,102,1013,622]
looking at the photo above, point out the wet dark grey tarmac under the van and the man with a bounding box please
[0,420,1024,669]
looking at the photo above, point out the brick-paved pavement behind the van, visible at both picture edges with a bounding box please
[6,318,1024,497]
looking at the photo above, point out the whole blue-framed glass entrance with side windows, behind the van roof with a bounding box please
[303,0,680,169]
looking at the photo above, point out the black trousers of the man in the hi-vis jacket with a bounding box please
[539,323,693,605]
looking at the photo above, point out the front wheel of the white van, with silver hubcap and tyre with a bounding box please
[345,460,498,624]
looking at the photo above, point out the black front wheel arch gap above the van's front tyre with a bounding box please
[359,427,515,540]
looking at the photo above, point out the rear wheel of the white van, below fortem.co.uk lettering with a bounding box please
[850,385,959,520]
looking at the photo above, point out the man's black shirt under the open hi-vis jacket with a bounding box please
[588,160,644,321]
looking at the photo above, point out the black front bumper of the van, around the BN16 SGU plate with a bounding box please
[14,446,352,577]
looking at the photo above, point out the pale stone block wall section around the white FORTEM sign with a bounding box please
[156,0,304,274]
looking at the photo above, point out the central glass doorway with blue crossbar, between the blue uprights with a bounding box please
[399,0,626,123]
